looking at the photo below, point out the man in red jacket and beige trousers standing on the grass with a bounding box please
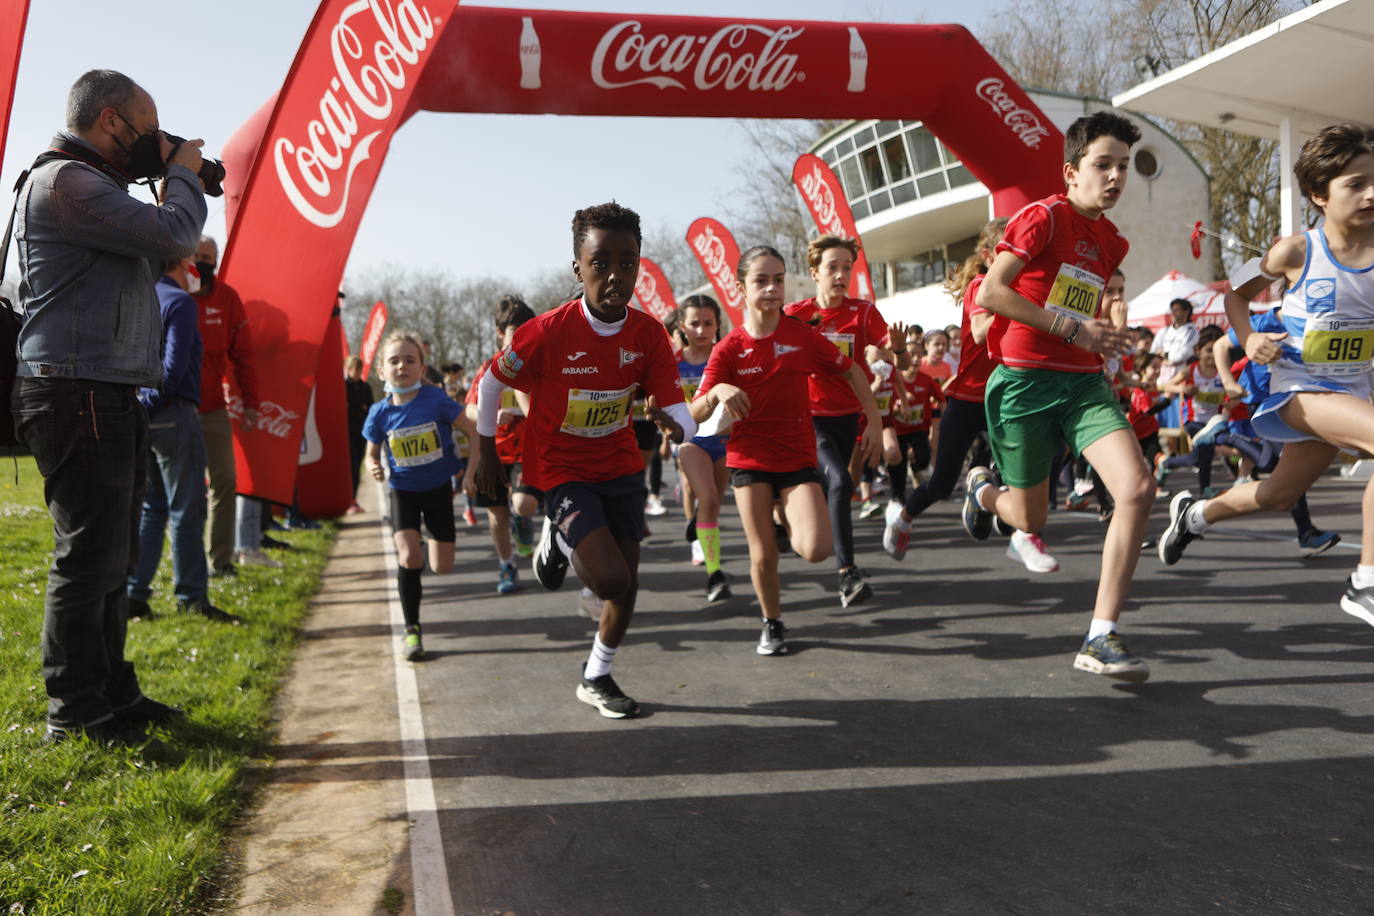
[192,235,259,575]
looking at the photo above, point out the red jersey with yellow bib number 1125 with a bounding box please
[492,299,683,490]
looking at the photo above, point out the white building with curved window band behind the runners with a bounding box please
[811,89,1210,330]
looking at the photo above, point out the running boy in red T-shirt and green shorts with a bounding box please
[963,111,1156,681]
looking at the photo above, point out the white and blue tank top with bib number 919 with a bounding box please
[1270,227,1374,398]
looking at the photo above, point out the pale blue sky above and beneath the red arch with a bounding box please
[0,0,1000,287]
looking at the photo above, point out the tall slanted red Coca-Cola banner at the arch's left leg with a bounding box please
[221,0,456,511]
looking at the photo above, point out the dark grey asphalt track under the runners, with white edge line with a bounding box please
[233,466,1374,916]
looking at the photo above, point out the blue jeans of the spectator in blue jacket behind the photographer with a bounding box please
[129,400,209,602]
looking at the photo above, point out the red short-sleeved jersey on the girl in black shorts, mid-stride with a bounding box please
[697,317,857,471]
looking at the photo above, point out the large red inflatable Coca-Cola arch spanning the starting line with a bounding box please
[223,0,1062,515]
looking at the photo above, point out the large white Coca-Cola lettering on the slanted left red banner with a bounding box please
[272,0,434,229]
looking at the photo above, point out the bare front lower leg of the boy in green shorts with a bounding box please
[1083,428,1156,621]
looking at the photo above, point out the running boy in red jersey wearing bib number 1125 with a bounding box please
[474,203,697,718]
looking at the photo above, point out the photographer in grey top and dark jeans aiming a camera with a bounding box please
[12,70,206,743]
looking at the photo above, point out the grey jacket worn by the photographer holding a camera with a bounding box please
[14,135,206,387]
